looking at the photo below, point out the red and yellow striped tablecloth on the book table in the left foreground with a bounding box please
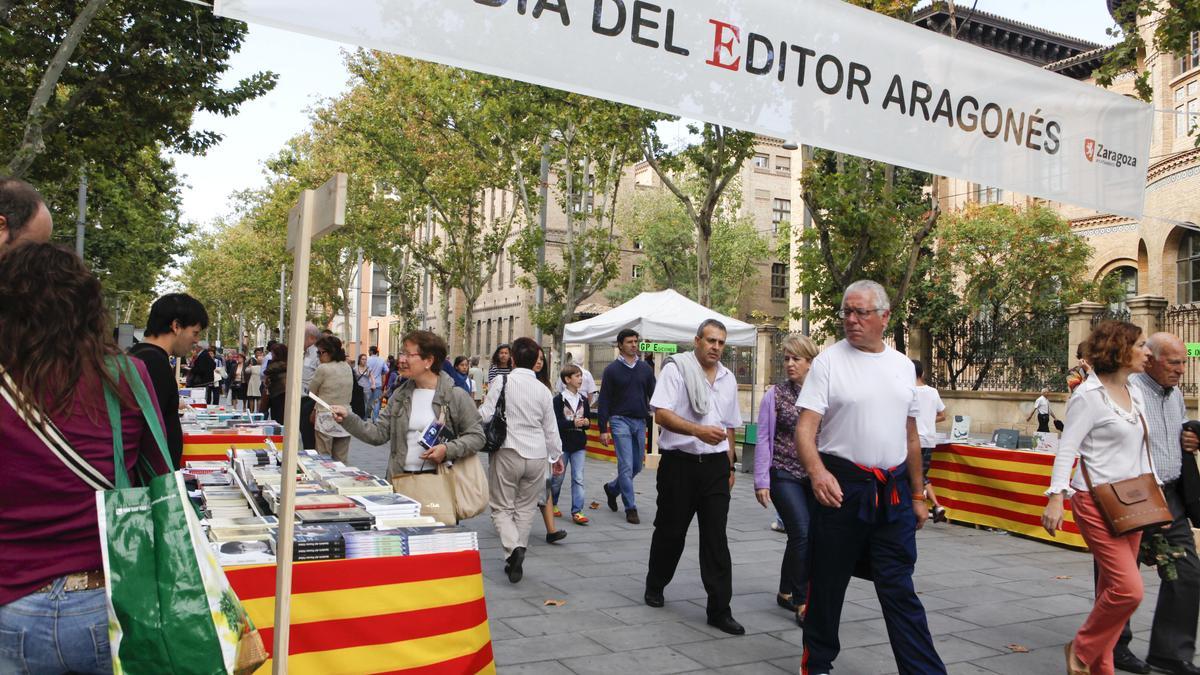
[226,551,496,675]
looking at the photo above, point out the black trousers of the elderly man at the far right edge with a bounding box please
[1117,480,1200,663]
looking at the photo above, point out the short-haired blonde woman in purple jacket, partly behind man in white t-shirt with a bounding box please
[754,334,821,625]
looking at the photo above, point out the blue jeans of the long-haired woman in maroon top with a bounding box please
[0,571,113,675]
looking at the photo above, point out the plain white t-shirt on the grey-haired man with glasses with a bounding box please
[796,340,918,468]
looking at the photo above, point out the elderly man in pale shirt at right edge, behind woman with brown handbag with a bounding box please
[1112,333,1200,675]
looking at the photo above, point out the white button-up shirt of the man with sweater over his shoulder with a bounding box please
[650,363,742,455]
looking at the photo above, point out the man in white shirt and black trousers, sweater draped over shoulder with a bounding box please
[644,319,745,635]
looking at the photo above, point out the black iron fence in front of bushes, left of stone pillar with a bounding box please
[926,313,1068,392]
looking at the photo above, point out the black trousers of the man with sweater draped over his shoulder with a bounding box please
[646,450,733,620]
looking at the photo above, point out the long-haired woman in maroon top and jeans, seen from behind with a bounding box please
[0,244,168,674]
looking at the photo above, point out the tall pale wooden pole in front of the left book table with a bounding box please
[271,190,316,675]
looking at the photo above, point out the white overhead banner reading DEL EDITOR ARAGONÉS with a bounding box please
[215,0,1152,217]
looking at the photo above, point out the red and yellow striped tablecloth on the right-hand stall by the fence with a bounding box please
[929,444,1087,549]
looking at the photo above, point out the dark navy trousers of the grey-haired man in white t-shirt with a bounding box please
[800,477,946,675]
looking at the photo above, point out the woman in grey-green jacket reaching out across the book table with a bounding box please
[334,330,484,525]
